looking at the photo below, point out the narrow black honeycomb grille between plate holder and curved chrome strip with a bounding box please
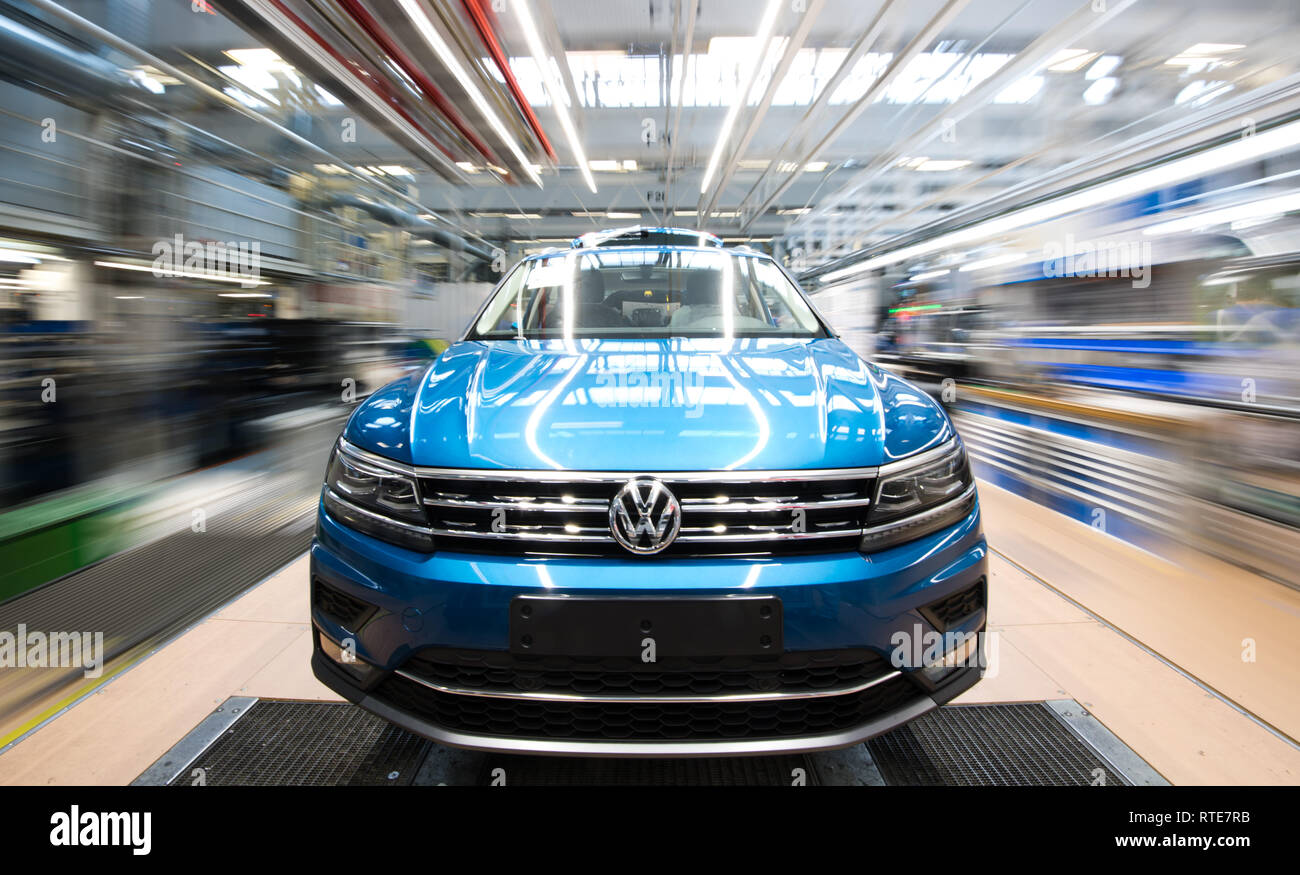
[402,649,892,697]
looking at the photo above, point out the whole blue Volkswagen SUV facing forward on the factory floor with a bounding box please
[311,229,988,757]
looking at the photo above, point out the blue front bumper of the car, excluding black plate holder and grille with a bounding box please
[311,494,988,757]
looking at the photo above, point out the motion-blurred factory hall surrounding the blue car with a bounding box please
[0,0,1300,741]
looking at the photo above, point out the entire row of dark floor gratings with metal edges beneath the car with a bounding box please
[144,698,1165,787]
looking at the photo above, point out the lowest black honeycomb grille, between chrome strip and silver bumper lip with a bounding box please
[372,675,922,741]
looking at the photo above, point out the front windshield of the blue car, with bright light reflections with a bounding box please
[469,247,827,339]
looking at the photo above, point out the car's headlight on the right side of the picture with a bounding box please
[859,438,975,553]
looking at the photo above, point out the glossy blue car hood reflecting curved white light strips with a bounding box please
[345,338,953,472]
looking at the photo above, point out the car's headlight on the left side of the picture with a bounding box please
[322,441,433,553]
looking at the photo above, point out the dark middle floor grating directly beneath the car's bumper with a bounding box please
[478,755,819,787]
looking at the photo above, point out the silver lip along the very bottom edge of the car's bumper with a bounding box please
[359,696,939,757]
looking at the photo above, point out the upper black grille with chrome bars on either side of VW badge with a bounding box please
[420,471,875,556]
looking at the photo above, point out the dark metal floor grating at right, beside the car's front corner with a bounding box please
[867,702,1128,787]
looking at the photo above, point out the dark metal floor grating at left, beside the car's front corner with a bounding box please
[170,699,430,787]
